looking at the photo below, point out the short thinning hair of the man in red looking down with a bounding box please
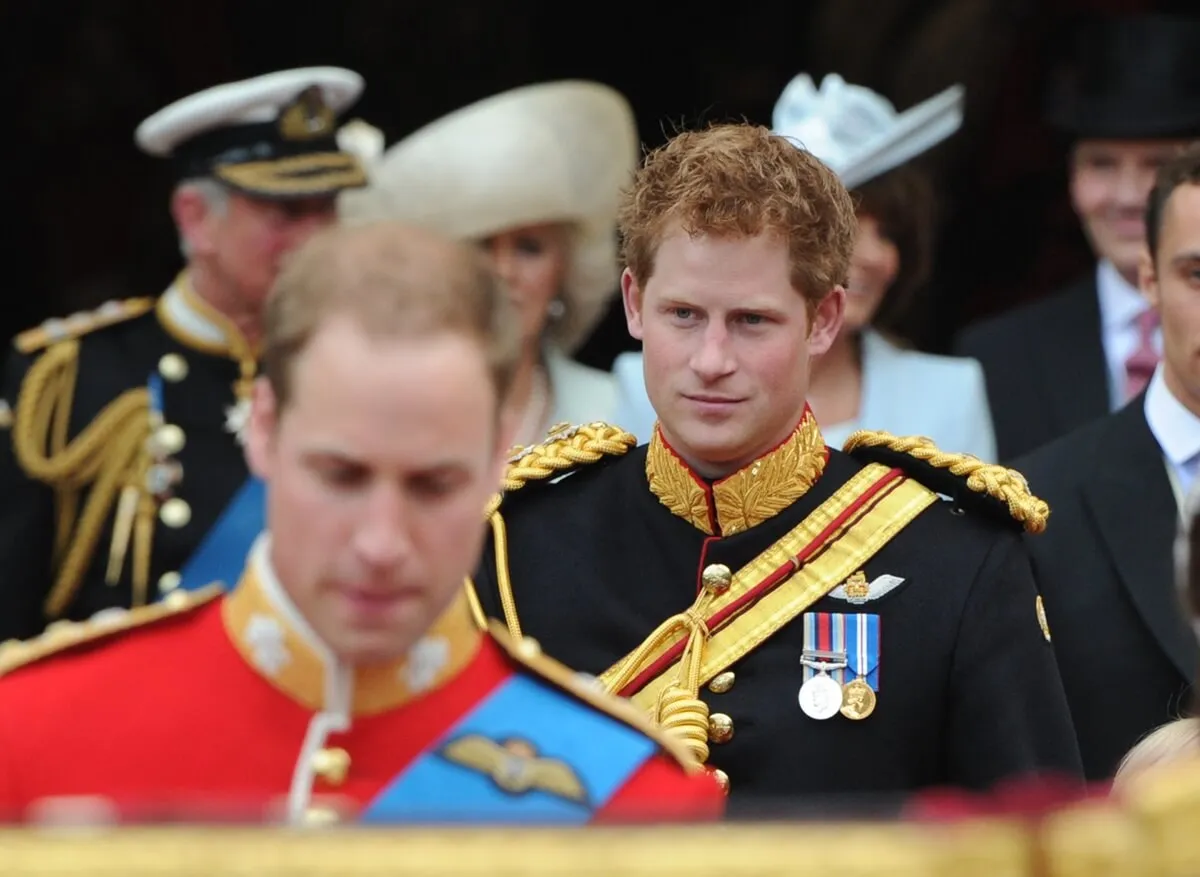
[263,222,521,409]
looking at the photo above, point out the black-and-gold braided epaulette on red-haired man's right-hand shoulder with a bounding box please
[842,430,1050,533]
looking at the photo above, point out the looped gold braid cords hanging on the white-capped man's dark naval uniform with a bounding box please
[12,340,154,619]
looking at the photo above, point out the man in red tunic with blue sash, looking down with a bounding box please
[0,224,724,824]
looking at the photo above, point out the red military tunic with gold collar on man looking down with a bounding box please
[0,557,724,823]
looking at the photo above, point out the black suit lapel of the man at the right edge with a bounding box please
[1084,395,1198,680]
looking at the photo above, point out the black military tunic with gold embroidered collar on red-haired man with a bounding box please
[475,425,1080,809]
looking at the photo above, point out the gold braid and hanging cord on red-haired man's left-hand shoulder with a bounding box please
[466,422,637,642]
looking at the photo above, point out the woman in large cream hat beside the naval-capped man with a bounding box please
[340,82,638,444]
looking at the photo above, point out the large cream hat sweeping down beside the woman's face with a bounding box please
[340,80,638,353]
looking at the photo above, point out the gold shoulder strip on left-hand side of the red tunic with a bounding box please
[0,584,224,677]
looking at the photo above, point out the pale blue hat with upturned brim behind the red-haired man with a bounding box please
[772,73,966,188]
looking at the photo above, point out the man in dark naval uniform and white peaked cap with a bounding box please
[0,67,366,642]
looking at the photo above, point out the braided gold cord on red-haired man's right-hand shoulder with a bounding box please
[842,430,1050,533]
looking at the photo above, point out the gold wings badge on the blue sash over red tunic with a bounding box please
[440,734,588,805]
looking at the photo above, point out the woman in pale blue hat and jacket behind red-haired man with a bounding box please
[614,74,996,459]
